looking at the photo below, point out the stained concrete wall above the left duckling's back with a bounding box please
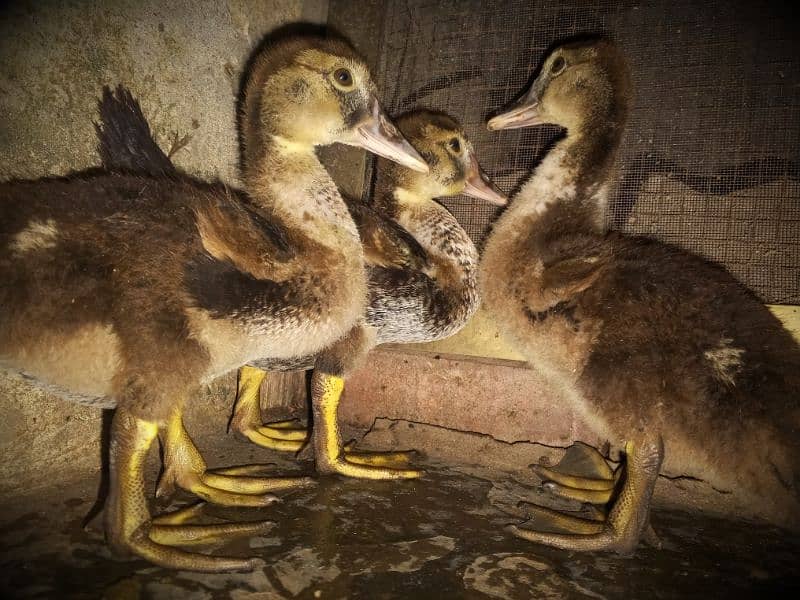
[0,0,304,181]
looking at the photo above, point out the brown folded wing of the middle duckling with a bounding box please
[345,198,428,271]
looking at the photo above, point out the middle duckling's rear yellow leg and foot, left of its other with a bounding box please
[231,366,307,452]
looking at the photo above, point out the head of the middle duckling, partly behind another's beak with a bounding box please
[380,110,507,206]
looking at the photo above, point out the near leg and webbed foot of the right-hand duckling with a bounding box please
[509,437,664,555]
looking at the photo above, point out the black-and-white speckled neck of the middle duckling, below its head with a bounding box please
[392,187,478,287]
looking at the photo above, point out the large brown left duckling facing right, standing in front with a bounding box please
[0,37,427,572]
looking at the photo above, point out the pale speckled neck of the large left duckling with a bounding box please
[244,135,358,241]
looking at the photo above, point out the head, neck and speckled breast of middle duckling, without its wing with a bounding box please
[367,110,505,342]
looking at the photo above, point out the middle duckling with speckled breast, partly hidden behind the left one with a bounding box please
[97,88,505,478]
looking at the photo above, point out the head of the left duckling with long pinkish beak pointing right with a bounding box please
[240,36,428,173]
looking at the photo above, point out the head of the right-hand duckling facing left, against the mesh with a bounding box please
[488,38,630,131]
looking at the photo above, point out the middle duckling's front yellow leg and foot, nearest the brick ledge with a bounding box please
[311,371,422,479]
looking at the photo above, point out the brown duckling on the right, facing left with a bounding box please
[479,39,800,553]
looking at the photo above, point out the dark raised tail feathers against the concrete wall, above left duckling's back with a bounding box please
[94,85,177,176]
